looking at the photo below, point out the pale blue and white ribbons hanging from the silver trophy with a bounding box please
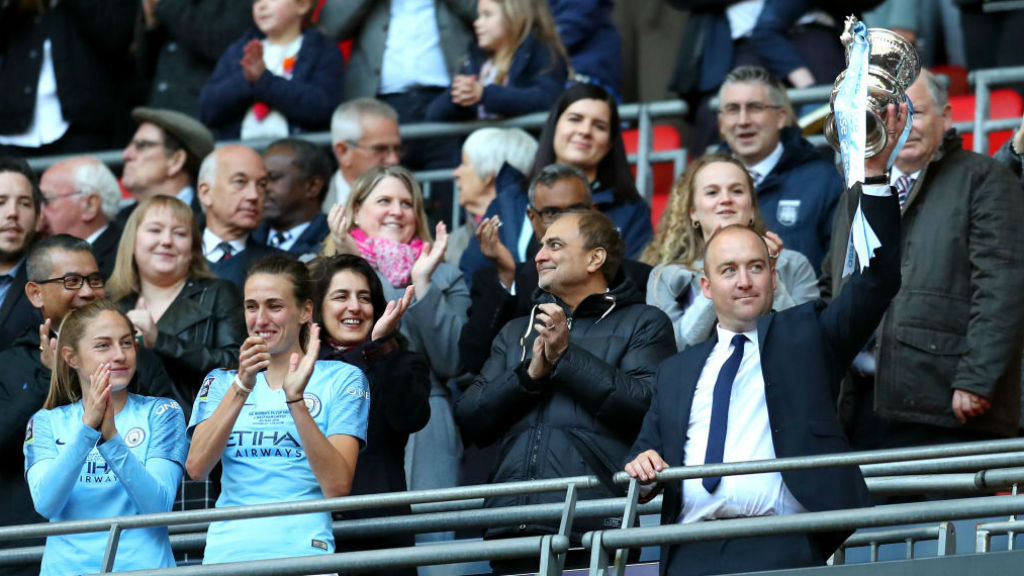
[833,19,913,278]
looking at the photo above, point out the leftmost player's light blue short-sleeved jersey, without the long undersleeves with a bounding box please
[25,394,188,576]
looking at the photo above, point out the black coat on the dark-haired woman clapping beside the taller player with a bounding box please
[321,336,430,574]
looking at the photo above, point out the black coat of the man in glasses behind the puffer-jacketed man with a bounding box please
[459,260,651,374]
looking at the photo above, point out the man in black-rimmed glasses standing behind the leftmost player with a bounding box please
[0,234,173,575]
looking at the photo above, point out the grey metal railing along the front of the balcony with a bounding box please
[0,439,1024,574]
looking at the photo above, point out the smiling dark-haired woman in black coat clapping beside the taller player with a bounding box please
[313,254,430,576]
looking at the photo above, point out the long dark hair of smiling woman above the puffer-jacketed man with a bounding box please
[529,84,641,203]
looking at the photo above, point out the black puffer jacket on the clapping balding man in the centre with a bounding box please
[456,280,676,541]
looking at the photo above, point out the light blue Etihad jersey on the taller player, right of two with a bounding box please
[188,361,370,564]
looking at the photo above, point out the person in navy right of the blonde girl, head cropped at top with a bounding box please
[548,0,623,97]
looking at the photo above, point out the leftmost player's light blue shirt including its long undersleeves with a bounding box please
[25,395,188,576]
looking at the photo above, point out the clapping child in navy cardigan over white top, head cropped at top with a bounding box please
[199,0,345,138]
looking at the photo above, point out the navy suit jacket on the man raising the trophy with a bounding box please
[629,189,900,570]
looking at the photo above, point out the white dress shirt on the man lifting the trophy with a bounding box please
[680,326,807,524]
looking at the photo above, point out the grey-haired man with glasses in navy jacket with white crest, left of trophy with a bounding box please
[718,66,843,271]
